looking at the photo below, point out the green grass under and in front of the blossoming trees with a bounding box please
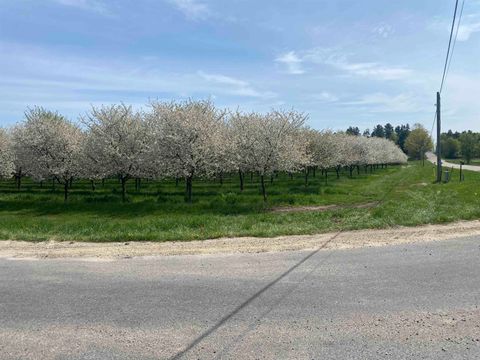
[0,162,480,241]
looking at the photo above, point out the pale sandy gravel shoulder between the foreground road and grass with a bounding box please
[0,220,480,261]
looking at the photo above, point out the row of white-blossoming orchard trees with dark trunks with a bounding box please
[0,100,407,201]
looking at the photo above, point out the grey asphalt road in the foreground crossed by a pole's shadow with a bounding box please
[0,237,480,359]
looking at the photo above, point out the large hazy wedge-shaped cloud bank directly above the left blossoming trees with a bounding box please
[0,42,276,122]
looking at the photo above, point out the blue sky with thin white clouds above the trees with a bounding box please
[0,0,480,131]
